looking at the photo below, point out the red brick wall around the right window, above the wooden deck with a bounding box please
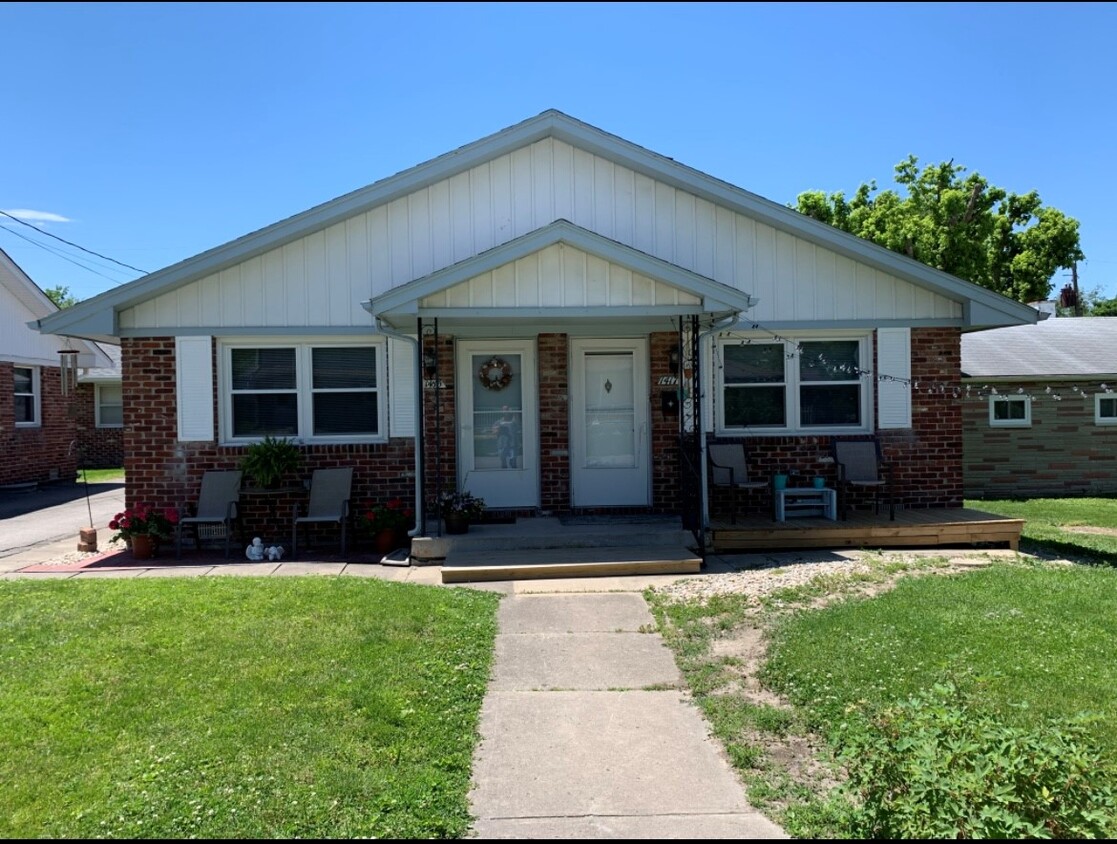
[720,328,962,508]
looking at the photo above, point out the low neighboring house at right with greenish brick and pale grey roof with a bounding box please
[962,317,1117,498]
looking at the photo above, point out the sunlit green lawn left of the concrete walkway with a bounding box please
[0,577,498,838]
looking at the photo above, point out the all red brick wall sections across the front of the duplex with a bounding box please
[120,328,962,539]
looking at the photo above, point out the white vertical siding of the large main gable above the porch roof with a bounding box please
[121,138,962,329]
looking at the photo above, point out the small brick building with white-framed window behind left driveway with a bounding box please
[75,343,124,469]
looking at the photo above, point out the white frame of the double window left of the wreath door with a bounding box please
[218,336,389,445]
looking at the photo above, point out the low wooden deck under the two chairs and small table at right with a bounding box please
[707,509,1024,554]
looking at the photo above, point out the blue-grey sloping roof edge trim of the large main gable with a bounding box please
[38,109,1037,338]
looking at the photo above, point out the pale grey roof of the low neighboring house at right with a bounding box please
[962,317,1117,378]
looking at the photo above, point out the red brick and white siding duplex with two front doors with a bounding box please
[34,111,1037,538]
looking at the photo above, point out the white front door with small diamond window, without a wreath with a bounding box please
[570,339,651,507]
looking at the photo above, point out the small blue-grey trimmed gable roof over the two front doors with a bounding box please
[362,220,756,328]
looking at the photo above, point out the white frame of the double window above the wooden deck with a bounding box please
[714,332,876,437]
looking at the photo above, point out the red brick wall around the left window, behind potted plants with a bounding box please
[121,337,414,544]
